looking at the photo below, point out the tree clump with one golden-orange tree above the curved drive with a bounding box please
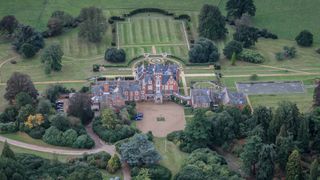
[0,73,94,148]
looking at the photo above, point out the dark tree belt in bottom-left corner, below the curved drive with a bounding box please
[0,142,103,180]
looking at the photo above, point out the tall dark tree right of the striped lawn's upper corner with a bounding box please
[198,4,228,40]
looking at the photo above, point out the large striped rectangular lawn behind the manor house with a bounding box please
[117,13,188,59]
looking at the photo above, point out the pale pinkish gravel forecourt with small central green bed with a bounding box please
[137,102,186,137]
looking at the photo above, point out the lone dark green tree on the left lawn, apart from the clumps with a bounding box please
[41,44,63,74]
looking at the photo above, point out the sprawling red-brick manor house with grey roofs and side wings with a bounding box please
[91,64,247,110]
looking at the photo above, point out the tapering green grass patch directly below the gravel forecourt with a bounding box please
[154,138,188,175]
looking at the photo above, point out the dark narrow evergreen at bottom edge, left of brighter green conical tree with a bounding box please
[256,144,276,180]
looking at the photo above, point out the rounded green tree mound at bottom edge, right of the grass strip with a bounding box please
[174,148,241,180]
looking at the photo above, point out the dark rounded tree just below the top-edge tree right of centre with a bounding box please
[233,25,259,48]
